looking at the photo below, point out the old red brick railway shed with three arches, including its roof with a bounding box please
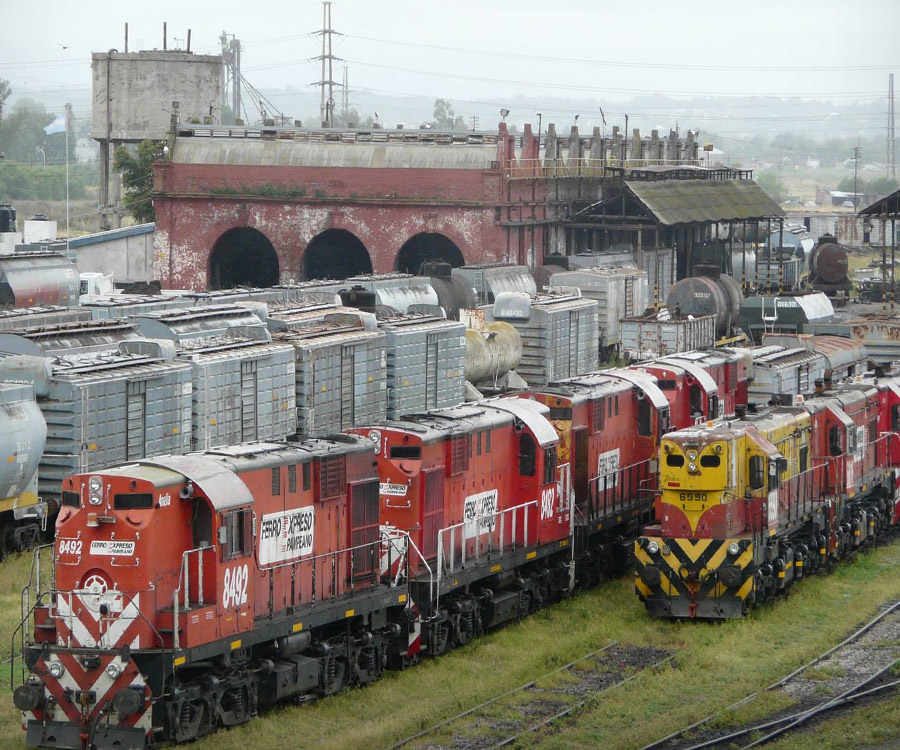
[153,123,780,289]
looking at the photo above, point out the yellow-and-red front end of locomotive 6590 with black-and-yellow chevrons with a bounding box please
[635,418,792,619]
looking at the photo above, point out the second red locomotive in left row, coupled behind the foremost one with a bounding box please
[354,398,572,660]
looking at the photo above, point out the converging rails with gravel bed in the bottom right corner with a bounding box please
[642,601,900,750]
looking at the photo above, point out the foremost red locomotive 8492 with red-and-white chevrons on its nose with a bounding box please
[13,436,407,750]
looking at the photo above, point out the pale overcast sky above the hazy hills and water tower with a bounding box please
[0,0,900,132]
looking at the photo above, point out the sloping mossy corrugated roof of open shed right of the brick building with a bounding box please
[625,180,785,226]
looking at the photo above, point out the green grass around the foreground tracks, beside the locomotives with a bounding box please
[0,544,900,750]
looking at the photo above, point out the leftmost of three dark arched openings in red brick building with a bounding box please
[209,227,279,289]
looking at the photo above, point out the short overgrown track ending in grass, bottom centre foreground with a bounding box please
[390,641,675,750]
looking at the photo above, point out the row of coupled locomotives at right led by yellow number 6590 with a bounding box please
[634,375,900,619]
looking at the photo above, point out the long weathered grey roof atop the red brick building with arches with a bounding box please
[172,138,497,169]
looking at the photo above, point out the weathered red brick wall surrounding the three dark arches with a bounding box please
[154,163,546,289]
